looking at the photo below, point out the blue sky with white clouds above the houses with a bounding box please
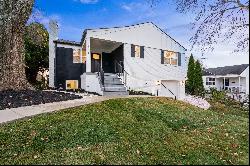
[34,0,249,67]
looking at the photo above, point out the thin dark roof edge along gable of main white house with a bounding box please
[81,22,187,50]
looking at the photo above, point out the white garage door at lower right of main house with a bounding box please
[159,80,179,98]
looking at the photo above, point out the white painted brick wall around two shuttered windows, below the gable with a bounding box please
[124,44,186,98]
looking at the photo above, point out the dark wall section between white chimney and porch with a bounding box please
[55,47,86,89]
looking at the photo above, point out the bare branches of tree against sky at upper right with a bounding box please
[149,0,249,52]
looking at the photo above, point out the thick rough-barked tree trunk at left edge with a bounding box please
[0,0,34,91]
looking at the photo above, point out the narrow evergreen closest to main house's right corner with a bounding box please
[186,54,195,95]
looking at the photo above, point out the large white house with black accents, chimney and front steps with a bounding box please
[49,22,187,99]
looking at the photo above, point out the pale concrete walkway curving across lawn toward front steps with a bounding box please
[0,96,149,124]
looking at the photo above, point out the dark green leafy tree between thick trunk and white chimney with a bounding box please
[24,23,49,85]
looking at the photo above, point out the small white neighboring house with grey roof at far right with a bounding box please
[203,64,249,94]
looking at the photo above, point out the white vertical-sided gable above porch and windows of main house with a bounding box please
[87,23,185,54]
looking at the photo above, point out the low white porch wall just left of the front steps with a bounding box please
[81,73,103,95]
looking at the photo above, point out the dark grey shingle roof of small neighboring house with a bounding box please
[203,64,249,76]
